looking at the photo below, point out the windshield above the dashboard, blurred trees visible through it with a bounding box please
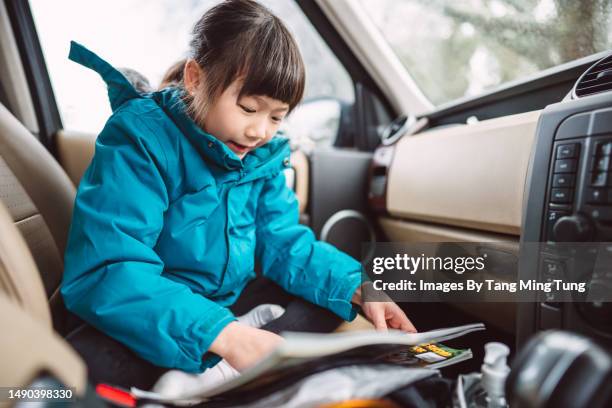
[358,0,612,105]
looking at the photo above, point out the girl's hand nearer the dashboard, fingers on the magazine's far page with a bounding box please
[352,287,417,333]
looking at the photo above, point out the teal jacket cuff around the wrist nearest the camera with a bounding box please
[174,307,237,373]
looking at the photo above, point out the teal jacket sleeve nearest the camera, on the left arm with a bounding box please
[61,112,235,373]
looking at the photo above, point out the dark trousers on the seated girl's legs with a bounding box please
[66,277,342,390]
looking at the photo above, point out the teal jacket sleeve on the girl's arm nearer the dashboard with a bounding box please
[256,172,362,321]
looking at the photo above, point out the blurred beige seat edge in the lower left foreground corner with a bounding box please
[0,199,87,406]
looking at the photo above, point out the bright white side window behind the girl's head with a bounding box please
[30,0,354,137]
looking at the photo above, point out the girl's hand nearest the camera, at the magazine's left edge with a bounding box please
[210,322,283,371]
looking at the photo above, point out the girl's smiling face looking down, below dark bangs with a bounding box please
[203,80,289,159]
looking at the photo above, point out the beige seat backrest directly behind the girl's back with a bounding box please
[0,104,76,334]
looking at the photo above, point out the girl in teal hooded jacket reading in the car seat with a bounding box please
[62,0,414,388]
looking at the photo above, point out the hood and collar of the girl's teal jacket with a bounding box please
[68,41,290,178]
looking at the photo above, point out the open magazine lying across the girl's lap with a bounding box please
[131,323,485,405]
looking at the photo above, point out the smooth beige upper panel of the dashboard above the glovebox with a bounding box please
[387,111,540,236]
